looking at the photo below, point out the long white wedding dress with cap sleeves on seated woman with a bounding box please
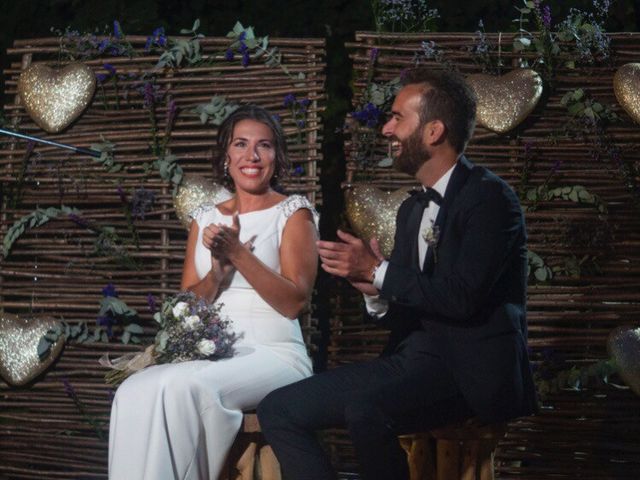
[109,195,317,480]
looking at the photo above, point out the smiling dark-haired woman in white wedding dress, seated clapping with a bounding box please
[109,105,317,480]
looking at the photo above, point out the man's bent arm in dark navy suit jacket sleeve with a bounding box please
[381,180,525,321]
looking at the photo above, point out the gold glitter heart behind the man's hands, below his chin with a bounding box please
[345,185,409,258]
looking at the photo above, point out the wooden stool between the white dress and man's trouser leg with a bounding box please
[219,413,282,480]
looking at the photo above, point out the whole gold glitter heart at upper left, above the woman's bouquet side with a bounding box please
[18,63,96,133]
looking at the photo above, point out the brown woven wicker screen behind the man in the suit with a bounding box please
[328,33,640,479]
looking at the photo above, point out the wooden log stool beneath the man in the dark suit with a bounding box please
[400,419,506,480]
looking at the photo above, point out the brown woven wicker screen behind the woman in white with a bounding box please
[0,36,325,479]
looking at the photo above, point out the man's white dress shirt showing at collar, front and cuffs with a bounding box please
[363,163,457,318]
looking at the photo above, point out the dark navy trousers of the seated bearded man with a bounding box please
[258,332,473,480]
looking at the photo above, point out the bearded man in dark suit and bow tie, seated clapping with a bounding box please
[258,69,536,480]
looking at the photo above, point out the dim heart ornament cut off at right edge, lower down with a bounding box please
[607,327,640,395]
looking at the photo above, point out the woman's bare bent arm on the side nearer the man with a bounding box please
[227,208,318,319]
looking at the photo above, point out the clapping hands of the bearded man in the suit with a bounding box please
[318,230,380,282]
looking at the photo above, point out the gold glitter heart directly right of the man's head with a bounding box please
[467,68,542,133]
